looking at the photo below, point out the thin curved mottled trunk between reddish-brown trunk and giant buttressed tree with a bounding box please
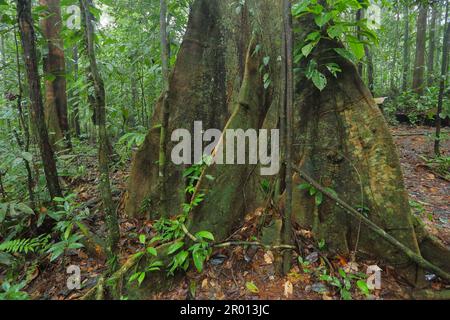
[80,0,120,269]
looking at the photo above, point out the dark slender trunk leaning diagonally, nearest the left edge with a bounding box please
[17,0,62,199]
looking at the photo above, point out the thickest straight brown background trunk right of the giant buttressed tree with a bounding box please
[412,3,428,95]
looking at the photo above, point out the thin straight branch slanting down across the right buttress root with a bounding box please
[293,166,450,281]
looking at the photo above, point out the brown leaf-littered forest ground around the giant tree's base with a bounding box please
[22,125,450,300]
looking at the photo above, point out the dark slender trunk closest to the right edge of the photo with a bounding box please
[434,0,450,156]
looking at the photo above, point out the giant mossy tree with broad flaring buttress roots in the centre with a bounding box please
[121,0,450,297]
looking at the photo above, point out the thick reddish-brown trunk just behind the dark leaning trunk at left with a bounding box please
[39,0,70,148]
